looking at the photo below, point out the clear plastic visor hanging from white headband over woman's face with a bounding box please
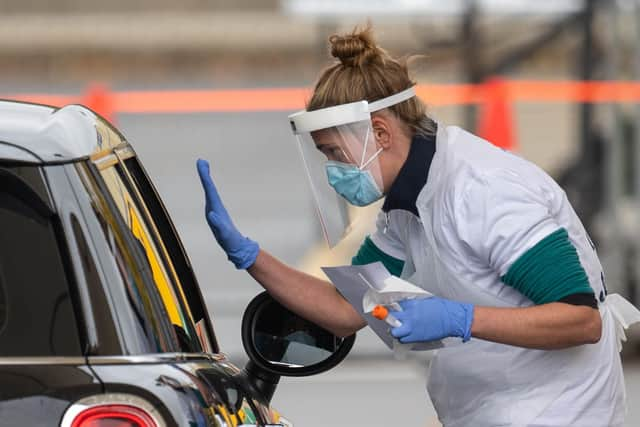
[296,120,383,247]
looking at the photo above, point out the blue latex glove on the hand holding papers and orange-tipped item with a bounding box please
[391,297,473,343]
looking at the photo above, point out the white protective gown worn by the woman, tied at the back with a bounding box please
[371,125,640,427]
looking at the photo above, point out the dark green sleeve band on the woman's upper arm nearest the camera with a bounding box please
[502,228,593,305]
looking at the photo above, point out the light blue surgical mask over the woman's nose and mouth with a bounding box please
[325,160,383,206]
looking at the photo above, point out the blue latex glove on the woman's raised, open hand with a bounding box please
[197,159,260,269]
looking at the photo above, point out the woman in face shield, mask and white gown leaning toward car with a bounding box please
[198,29,640,426]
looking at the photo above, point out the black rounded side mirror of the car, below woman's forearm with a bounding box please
[242,292,356,376]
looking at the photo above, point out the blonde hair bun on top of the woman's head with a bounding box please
[329,27,382,67]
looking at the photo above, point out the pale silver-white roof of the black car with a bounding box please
[0,100,124,164]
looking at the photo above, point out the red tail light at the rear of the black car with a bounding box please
[71,405,158,427]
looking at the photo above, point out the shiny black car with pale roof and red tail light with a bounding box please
[0,101,355,427]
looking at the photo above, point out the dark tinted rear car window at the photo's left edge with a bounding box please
[0,166,82,357]
